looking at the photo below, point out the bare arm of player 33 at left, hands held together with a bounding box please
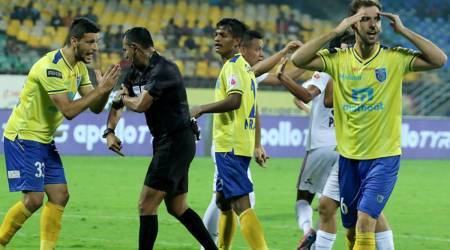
[50,65,120,120]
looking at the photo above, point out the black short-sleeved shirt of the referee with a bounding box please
[125,52,190,139]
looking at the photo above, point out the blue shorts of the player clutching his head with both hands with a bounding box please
[339,155,400,228]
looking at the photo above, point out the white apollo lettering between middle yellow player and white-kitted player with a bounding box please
[261,121,308,147]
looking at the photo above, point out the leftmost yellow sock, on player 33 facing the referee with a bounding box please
[0,201,31,246]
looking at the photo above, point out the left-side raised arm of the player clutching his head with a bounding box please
[291,12,365,71]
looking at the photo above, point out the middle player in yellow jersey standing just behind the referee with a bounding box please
[191,18,267,249]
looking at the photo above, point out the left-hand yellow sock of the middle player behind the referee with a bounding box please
[217,209,237,250]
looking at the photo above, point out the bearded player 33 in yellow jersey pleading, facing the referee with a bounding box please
[0,18,120,250]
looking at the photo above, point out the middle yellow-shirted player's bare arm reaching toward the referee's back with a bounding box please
[191,93,242,118]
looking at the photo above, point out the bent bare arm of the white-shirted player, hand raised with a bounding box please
[277,59,320,103]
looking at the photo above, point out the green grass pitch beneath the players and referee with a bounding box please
[0,156,450,250]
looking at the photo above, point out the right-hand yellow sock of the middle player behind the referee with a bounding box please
[239,208,268,250]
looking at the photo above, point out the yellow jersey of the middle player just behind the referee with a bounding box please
[213,54,257,157]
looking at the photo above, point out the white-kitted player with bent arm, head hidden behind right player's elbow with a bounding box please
[277,61,339,249]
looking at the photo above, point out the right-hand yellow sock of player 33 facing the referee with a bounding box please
[40,202,64,250]
